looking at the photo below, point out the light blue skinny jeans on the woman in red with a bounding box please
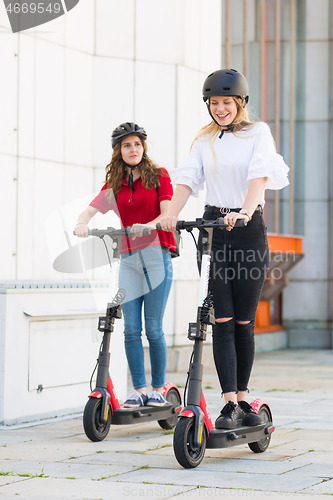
[119,246,172,389]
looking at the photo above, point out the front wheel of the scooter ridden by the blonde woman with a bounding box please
[173,417,206,469]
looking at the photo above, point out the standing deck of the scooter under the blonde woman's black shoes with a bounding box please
[206,422,274,448]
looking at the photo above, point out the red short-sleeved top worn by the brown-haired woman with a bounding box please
[90,170,175,253]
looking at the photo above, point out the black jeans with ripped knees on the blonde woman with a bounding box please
[199,210,269,393]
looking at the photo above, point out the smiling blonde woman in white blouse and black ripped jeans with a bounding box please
[161,69,289,429]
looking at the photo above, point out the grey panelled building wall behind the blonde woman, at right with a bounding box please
[222,0,333,348]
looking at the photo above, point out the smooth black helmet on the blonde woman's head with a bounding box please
[202,69,249,104]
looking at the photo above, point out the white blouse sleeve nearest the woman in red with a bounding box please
[172,140,205,196]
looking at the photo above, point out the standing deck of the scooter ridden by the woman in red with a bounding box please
[111,403,181,425]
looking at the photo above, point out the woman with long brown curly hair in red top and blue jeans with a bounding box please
[75,122,175,408]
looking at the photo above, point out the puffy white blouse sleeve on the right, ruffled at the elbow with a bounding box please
[247,122,289,189]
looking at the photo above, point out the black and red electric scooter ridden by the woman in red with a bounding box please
[75,227,182,441]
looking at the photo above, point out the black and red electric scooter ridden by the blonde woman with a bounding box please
[160,217,274,468]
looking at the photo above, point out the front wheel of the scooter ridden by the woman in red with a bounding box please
[83,398,111,441]
